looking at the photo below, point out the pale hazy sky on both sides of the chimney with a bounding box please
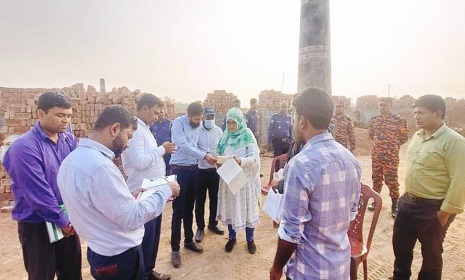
[0,0,465,105]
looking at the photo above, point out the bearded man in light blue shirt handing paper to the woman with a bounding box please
[170,102,216,268]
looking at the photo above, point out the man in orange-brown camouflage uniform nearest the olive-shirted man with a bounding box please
[368,97,409,218]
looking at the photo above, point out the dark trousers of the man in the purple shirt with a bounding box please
[18,222,82,280]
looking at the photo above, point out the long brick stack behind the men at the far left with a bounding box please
[0,84,175,204]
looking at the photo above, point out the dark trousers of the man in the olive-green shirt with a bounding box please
[392,194,455,280]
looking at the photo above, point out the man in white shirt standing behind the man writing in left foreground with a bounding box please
[121,94,175,280]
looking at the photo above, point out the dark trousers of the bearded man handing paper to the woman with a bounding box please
[171,166,197,251]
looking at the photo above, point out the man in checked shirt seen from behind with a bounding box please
[270,88,361,280]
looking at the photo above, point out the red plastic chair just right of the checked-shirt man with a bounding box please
[347,184,382,280]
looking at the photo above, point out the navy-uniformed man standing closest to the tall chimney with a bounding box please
[268,101,292,157]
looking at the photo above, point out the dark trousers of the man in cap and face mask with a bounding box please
[195,168,220,229]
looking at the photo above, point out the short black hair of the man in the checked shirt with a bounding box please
[292,88,333,129]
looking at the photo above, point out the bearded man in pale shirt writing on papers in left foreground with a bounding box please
[57,106,180,280]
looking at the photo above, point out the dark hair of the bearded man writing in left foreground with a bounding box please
[93,105,137,131]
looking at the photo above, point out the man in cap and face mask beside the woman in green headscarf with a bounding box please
[195,107,224,243]
